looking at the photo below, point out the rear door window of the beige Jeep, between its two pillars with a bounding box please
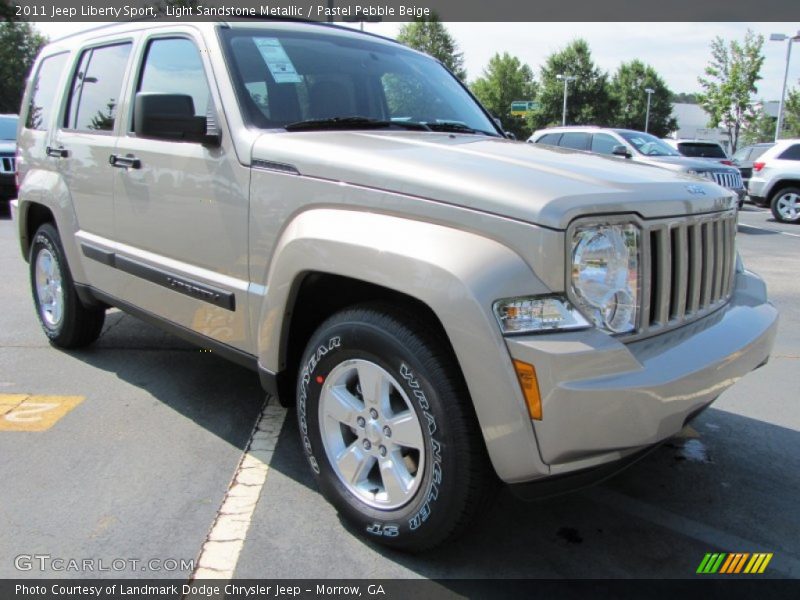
[65,43,131,131]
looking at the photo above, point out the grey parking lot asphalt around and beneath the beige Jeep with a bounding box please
[0,206,800,587]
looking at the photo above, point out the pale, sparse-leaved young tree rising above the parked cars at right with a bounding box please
[697,29,764,152]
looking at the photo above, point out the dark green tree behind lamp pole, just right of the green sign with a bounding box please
[531,39,612,129]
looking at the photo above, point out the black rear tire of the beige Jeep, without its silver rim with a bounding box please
[29,223,106,348]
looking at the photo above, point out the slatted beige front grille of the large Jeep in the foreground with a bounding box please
[635,212,736,337]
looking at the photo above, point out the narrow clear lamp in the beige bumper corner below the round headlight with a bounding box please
[493,296,590,333]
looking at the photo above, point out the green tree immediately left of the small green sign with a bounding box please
[470,52,536,139]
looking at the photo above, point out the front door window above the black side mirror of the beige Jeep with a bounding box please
[137,38,211,122]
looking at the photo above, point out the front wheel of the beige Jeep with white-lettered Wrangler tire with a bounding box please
[297,307,493,550]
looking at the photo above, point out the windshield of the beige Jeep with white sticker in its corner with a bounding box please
[220,27,499,136]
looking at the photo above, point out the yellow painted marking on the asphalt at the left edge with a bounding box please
[0,394,84,431]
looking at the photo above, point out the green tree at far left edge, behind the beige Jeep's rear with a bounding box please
[0,21,47,113]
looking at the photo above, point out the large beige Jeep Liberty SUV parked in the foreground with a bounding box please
[14,21,777,549]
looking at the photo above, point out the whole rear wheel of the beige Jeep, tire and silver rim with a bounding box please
[30,223,106,348]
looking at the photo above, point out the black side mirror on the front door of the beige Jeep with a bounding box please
[133,92,220,146]
